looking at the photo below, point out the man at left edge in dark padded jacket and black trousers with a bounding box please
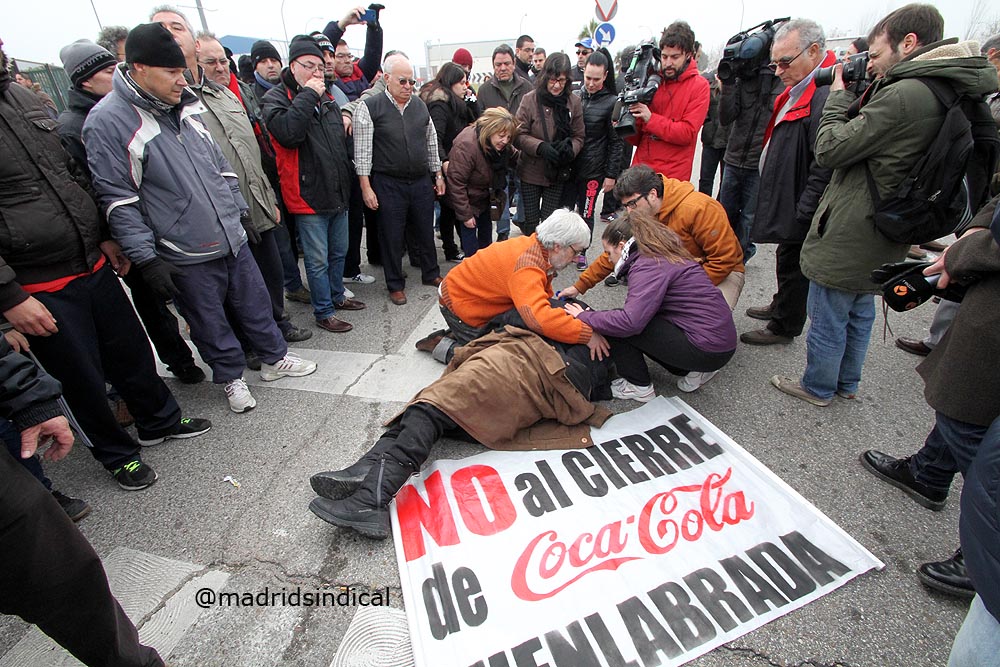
[0,31,211,491]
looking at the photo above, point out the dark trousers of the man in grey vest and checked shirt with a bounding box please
[371,174,441,292]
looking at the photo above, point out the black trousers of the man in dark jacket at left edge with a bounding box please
[30,266,181,470]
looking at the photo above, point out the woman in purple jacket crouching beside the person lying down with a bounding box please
[566,210,736,403]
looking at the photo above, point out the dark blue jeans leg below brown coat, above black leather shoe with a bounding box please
[910,412,987,491]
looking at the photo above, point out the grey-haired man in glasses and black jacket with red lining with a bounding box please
[740,19,837,345]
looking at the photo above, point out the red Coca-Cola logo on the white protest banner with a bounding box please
[510,468,754,602]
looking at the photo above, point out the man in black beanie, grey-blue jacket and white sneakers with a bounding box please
[83,23,316,412]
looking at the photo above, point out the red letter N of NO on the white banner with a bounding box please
[396,470,458,562]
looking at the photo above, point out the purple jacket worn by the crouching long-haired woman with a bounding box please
[579,252,736,352]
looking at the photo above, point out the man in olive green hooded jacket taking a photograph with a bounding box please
[771,5,997,406]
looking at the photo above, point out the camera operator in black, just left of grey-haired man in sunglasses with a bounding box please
[718,19,788,262]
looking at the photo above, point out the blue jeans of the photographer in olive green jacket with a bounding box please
[796,280,875,398]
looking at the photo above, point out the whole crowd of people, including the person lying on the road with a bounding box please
[0,4,1000,667]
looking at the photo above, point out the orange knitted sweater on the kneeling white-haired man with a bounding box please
[441,234,593,343]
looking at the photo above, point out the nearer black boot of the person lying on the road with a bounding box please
[309,454,416,540]
